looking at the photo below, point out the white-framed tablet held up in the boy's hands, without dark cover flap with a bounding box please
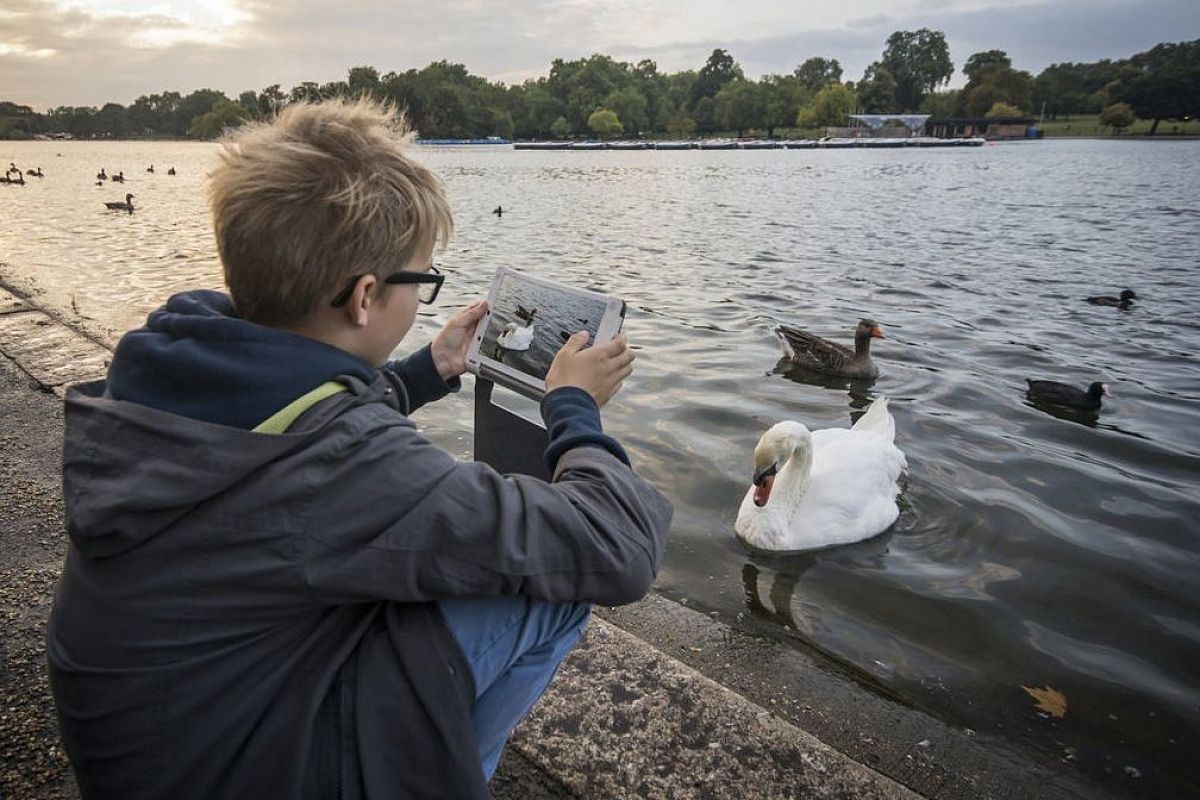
[467,266,625,398]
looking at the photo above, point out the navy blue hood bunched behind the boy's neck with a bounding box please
[107,290,377,429]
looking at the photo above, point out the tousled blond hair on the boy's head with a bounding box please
[209,100,454,326]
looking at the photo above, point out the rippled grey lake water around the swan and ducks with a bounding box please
[0,140,1200,796]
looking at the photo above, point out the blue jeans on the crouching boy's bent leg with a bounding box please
[438,597,592,780]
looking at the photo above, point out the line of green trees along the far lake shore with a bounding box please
[0,35,1200,139]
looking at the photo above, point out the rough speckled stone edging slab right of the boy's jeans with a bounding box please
[511,618,920,800]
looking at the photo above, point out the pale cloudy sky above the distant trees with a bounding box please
[0,0,1200,110]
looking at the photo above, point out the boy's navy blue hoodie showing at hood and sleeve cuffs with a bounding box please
[106,289,629,473]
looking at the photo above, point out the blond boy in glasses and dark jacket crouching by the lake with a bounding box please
[47,102,671,799]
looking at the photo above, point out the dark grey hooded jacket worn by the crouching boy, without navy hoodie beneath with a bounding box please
[47,371,671,799]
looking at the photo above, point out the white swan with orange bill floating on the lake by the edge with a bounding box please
[734,397,908,551]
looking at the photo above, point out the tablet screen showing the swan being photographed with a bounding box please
[479,272,607,380]
